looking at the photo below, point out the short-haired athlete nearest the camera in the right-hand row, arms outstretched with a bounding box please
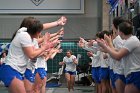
[98,22,140,93]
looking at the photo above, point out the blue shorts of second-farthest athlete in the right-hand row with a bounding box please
[99,68,109,81]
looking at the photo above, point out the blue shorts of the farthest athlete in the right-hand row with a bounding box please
[92,67,101,84]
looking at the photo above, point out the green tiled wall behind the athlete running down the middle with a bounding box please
[48,41,89,73]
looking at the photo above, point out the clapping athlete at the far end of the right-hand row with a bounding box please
[78,35,101,93]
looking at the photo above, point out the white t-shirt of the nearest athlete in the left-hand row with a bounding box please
[5,28,33,74]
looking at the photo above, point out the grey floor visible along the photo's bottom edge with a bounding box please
[0,85,95,93]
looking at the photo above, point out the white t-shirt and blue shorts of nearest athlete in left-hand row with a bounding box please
[0,27,33,87]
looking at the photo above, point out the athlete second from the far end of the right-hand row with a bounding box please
[97,30,110,93]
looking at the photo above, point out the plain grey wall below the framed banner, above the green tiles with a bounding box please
[0,0,102,39]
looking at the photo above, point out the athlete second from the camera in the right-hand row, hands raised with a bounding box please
[104,17,125,93]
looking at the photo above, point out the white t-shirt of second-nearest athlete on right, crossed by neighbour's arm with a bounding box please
[113,35,124,75]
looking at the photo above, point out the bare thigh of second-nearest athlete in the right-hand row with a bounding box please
[115,79,125,93]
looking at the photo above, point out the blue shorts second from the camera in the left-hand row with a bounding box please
[24,69,35,83]
